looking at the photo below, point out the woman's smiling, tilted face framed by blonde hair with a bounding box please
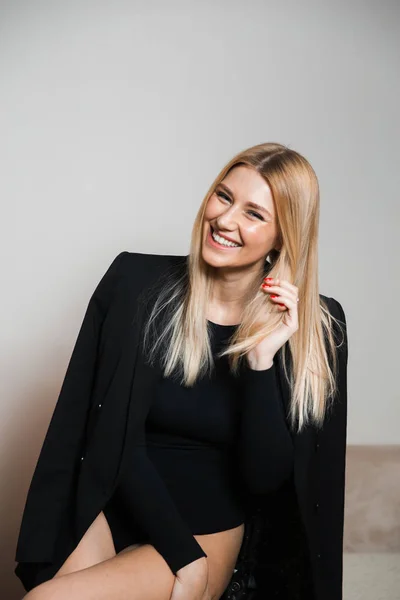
[202,165,279,267]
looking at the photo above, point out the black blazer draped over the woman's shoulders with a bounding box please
[15,252,347,600]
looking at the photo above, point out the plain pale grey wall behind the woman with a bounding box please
[0,0,400,600]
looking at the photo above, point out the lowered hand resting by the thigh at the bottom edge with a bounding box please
[170,556,211,600]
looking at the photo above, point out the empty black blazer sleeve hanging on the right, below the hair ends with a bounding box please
[316,298,348,600]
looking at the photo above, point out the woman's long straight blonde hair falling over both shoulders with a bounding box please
[143,143,346,432]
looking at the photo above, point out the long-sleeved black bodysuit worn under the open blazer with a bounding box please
[103,321,293,574]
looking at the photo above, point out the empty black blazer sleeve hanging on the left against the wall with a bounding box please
[16,251,129,562]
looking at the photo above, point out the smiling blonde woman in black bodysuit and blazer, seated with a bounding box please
[16,143,347,600]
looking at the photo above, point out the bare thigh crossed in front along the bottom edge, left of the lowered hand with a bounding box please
[24,544,175,600]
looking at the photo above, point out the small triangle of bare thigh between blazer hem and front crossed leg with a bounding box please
[54,512,115,577]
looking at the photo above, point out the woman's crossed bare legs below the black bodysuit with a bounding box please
[24,513,244,600]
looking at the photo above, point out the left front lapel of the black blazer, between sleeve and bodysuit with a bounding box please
[75,262,167,539]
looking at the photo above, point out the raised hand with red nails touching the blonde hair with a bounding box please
[247,277,299,370]
